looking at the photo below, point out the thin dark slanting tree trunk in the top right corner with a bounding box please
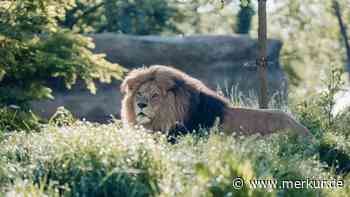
[333,0,350,82]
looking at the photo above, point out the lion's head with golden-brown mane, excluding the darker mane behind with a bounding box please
[121,66,194,132]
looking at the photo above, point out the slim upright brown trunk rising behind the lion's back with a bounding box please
[257,0,268,108]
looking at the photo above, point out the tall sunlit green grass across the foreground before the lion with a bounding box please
[0,117,350,196]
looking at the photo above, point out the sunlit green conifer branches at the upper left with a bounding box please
[0,0,122,106]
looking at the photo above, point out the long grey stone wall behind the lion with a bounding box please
[32,33,287,122]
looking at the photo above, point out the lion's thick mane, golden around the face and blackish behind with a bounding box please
[121,66,228,131]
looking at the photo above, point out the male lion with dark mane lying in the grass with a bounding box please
[121,65,310,141]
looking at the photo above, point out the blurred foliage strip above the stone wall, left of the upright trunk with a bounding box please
[60,0,254,35]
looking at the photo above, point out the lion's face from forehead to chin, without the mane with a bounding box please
[133,81,172,125]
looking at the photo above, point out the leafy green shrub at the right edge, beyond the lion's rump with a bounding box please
[298,68,350,173]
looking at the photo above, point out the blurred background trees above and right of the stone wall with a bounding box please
[60,0,350,92]
